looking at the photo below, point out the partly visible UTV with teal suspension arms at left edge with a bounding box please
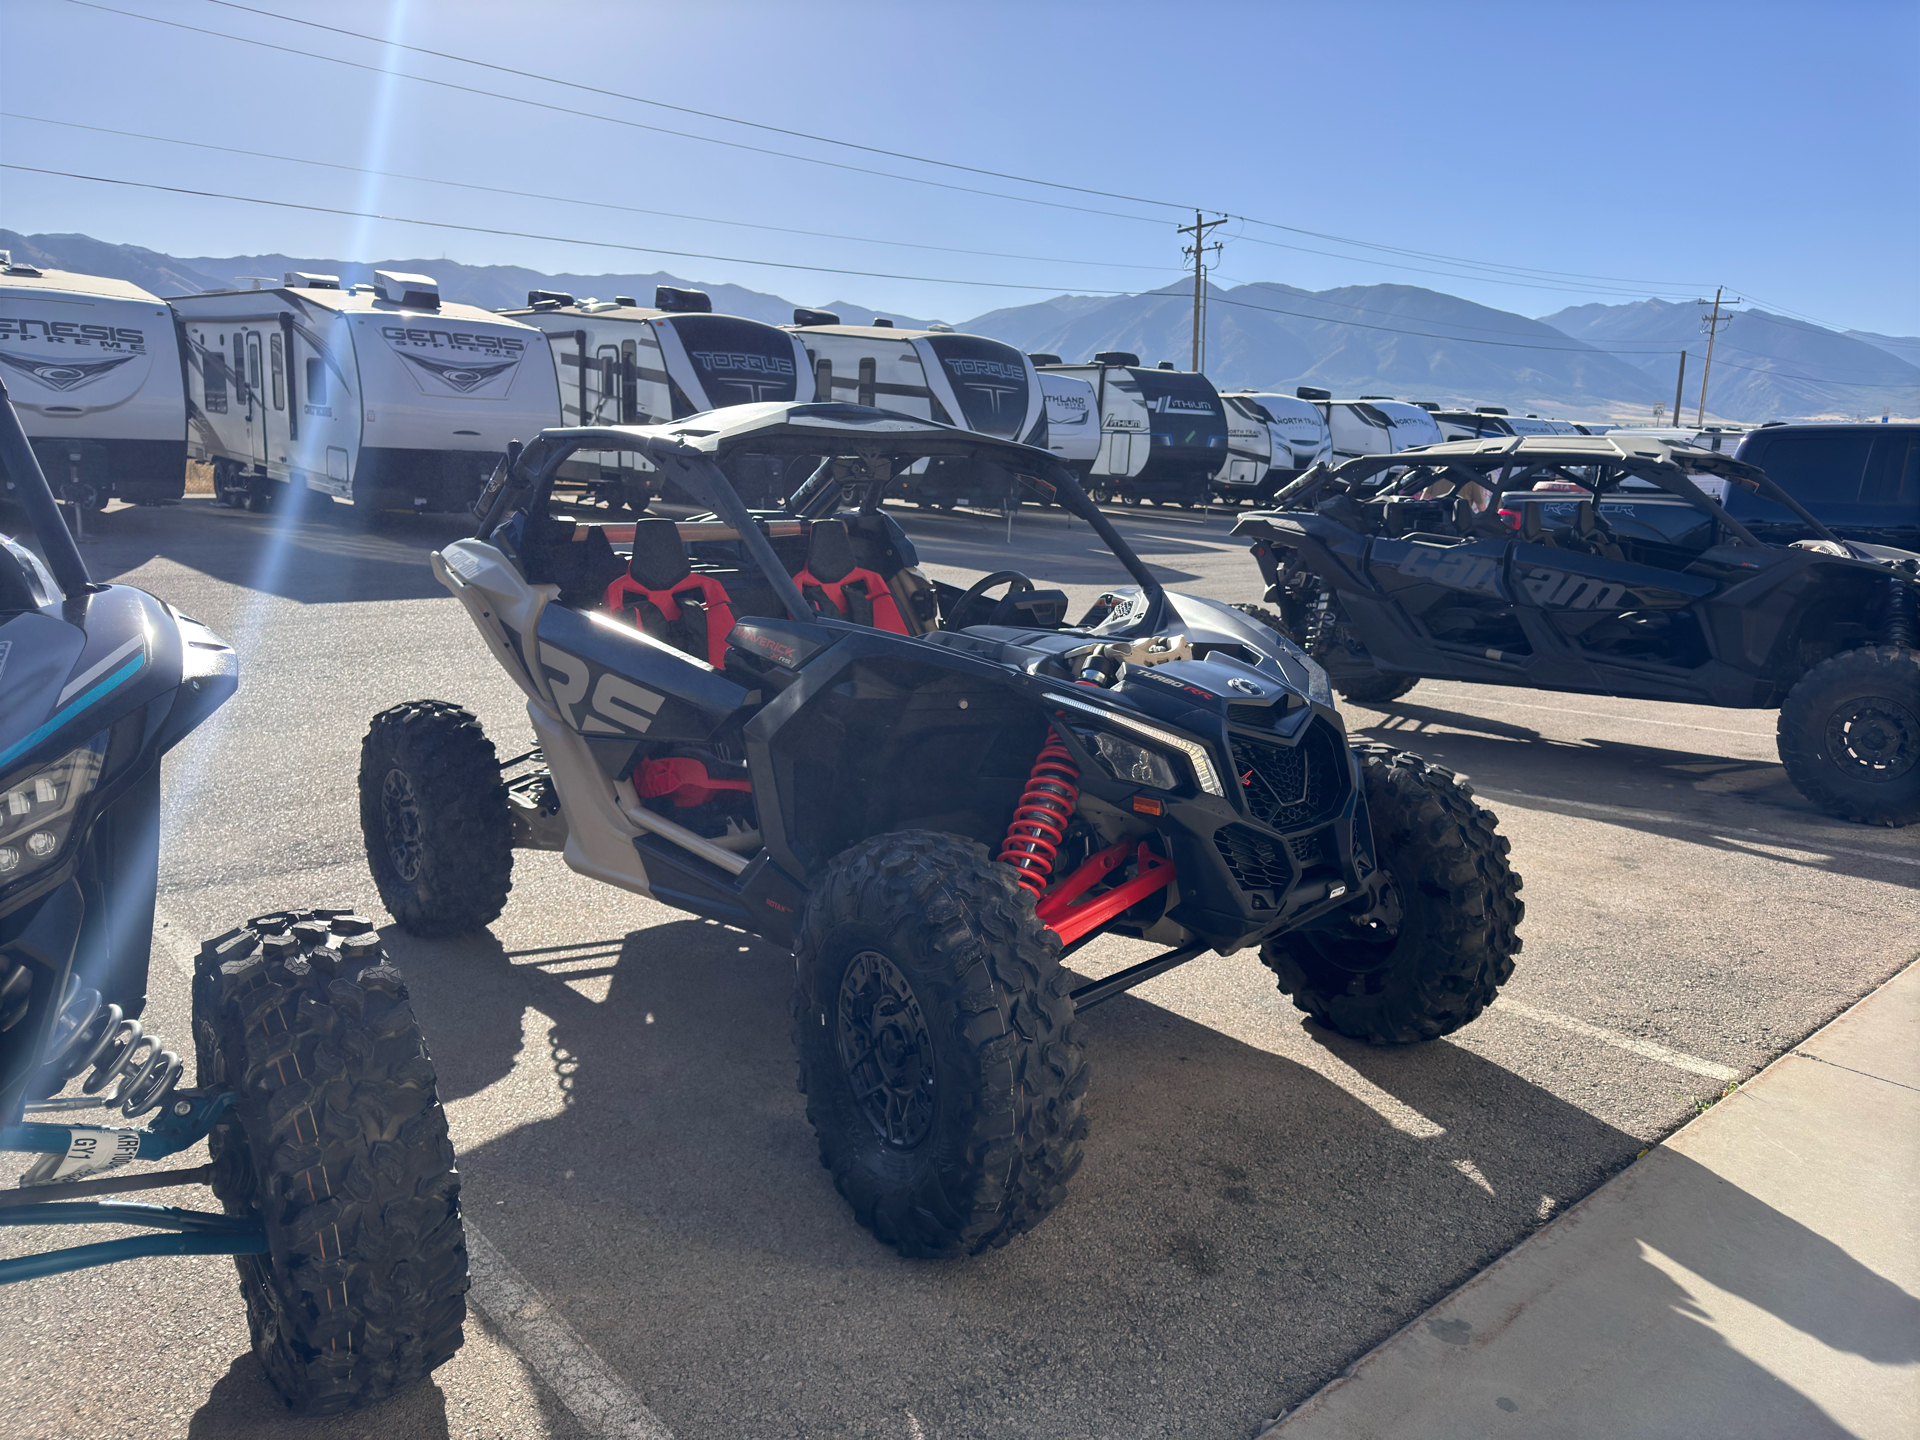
[0,386,467,1415]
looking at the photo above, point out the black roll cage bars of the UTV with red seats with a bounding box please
[474,416,1171,634]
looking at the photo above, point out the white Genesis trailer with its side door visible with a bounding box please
[173,271,559,511]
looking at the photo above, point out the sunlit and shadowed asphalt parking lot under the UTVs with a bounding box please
[0,499,1920,1440]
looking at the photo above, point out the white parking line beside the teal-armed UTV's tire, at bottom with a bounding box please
[467,1223,674,1440]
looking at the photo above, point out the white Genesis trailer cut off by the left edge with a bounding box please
[0,250,186,511]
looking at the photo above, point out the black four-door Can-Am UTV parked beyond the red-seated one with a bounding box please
[1233,436,1920,826]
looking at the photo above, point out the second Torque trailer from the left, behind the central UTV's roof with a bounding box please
[793,309,1048,509]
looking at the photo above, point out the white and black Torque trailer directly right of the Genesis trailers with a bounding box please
[501,284,812,513]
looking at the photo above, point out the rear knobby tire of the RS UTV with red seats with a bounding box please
[359,701,513,935]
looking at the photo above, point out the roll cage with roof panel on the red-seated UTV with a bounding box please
[474,401,1173,636]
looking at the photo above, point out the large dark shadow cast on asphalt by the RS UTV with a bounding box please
[370,920,1904,1436]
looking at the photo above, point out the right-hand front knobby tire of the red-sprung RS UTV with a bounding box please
[1260,745,1526,1044]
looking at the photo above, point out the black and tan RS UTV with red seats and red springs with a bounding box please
[361,403,1521,1256]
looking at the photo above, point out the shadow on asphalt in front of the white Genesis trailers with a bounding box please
[68,497,460,605]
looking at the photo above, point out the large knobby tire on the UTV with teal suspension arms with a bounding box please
[194,910,467,1415]
